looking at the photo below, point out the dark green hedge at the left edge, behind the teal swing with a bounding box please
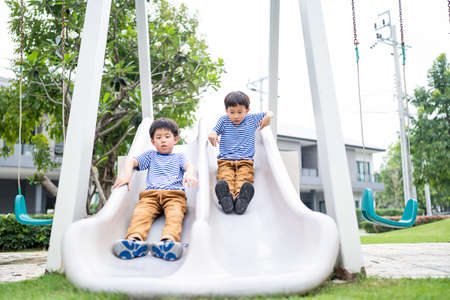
[0,214,52,251]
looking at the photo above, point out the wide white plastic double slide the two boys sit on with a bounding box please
[62,119,338,297]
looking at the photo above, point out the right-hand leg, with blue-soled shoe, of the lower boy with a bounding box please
[150,191,187,260]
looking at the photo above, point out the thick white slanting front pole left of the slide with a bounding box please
[47,0,111,272]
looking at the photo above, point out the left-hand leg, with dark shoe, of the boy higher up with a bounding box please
[215,159,236,214]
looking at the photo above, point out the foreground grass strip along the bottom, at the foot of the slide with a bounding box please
[0,274,450,300]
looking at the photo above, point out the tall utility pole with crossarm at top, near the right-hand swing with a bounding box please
[370,11,416,204]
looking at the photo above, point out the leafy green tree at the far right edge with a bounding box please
[409,54,450,210]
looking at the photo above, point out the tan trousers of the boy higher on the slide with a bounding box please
[217,159,255,198]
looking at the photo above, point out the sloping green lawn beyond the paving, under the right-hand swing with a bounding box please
[361,218,450,244]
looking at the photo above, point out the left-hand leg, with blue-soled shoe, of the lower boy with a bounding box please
[113,191,161,259]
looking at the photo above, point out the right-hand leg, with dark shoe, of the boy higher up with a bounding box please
[234,160,255,215]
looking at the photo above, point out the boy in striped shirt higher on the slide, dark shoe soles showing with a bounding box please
[208,91,272,215]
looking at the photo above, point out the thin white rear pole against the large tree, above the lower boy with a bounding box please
[135,0,153,119]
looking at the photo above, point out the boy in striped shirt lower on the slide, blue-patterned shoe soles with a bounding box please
[113,118,198,260]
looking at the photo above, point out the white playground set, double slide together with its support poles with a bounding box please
[43,0,363,296]
